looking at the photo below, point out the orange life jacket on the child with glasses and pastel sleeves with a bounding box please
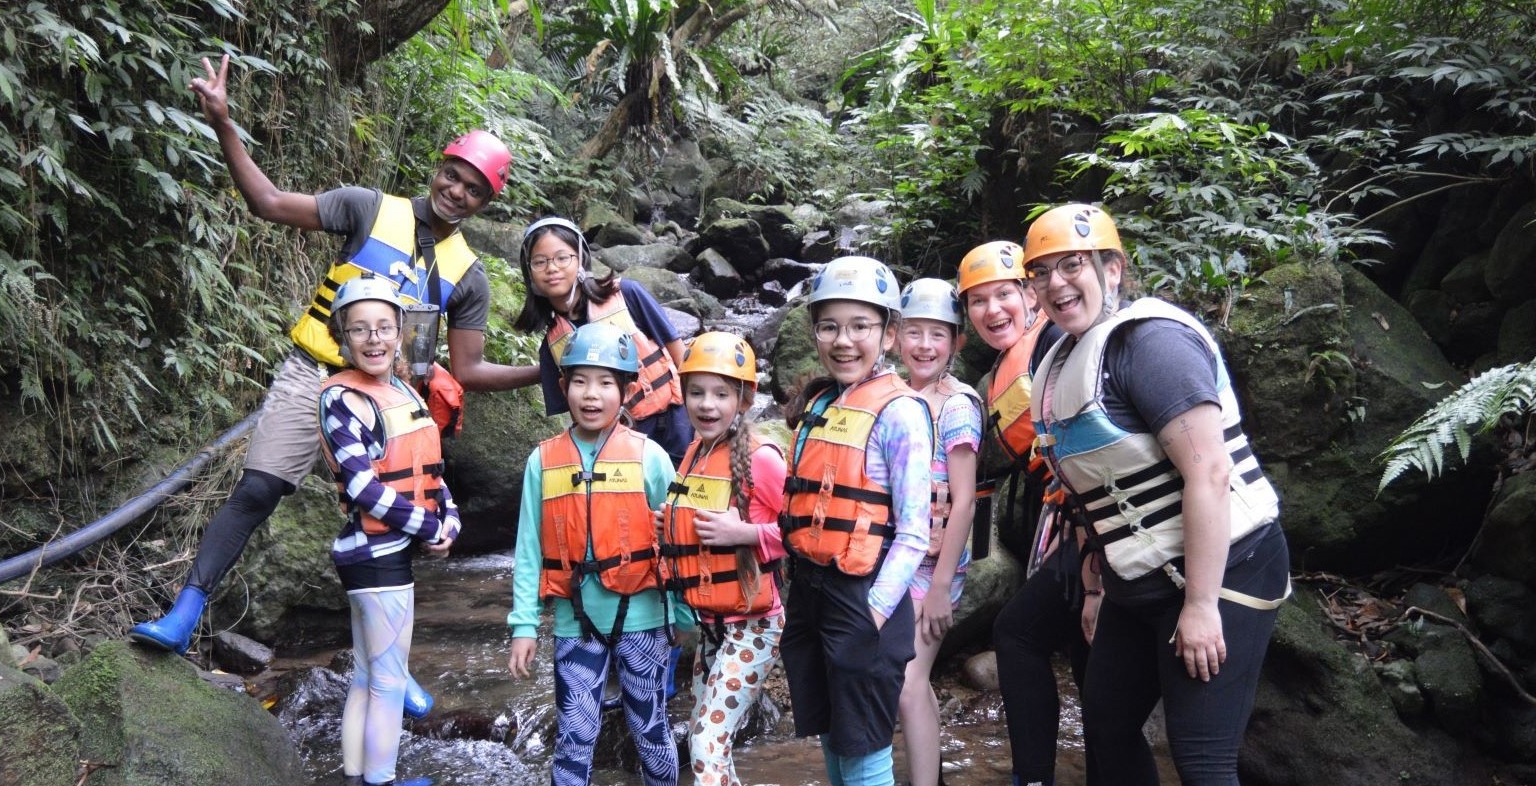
[780,373,917,576]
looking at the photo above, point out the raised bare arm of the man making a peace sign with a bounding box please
[187,55,321,230]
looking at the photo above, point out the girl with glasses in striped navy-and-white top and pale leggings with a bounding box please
[319,273,459,786]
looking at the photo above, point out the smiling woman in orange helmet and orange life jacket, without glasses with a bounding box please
[960,241,1101,786]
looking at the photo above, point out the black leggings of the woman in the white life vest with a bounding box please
[1083,527,1290,786]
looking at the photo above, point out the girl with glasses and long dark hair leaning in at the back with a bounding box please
[513,218,693,465]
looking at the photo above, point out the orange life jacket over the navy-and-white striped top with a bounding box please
[321,368,442,534]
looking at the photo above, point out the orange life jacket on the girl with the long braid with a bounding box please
[662,438,777,614]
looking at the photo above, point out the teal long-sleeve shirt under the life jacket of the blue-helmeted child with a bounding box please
[507,431,677,639]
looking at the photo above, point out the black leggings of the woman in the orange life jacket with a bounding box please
[992,559,1098,786]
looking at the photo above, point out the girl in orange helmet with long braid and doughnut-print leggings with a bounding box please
[660,332,785,786]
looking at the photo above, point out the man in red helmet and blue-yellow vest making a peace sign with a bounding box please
[129,55,513,714]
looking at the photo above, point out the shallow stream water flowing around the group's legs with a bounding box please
[272,554,1178,786]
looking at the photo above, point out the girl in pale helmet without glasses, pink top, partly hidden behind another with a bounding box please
[897,278,982,786]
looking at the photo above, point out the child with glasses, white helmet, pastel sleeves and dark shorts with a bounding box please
[780,256,934,786]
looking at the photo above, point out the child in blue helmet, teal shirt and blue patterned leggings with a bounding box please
[507,322,677,786]
